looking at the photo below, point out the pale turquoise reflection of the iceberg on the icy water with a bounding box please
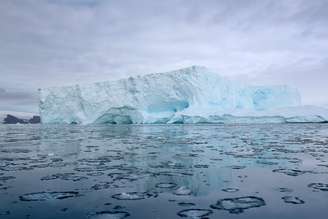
[37,125,297,196]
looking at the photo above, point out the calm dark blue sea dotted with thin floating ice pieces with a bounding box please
[0,124,328,219]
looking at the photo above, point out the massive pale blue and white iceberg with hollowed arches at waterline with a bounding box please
[40,66,328,124]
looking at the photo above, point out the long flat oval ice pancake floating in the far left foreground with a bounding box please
[19,191,79,201]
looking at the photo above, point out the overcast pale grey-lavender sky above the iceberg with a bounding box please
[0,0,328,112]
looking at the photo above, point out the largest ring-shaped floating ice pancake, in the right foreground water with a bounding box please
[211,196,265,214]
